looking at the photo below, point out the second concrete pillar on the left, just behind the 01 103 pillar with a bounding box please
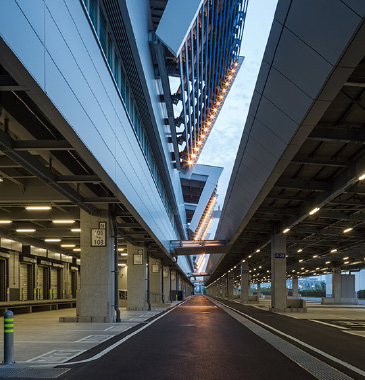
[127,243,147,310]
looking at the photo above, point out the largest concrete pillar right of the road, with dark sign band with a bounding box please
[271,234,286,311]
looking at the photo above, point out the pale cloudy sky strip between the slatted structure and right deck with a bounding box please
[198,0,277,211]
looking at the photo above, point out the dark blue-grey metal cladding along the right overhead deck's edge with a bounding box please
[215,0,363,243]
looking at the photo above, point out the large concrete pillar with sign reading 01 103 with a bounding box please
[78,210,114,323]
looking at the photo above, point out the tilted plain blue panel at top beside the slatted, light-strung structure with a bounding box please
[156,0,204,57]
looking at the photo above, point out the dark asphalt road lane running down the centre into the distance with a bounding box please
[60,296,314,380]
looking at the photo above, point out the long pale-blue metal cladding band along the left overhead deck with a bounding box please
[0,0,177,249]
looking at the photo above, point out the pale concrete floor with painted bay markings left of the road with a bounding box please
[0,304,171,364]
